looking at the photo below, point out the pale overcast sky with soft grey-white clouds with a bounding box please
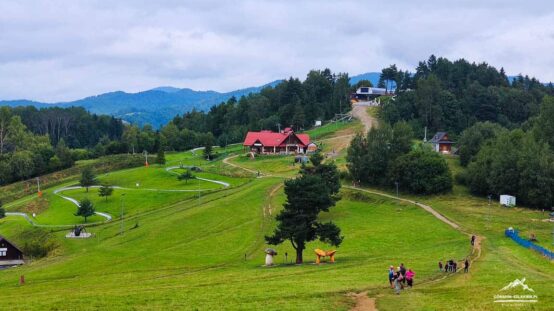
[0,0,554,102]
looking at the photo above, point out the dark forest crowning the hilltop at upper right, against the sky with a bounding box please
[381,55,554,137]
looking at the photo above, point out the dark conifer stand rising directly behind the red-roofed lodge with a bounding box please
[161,69,352,150]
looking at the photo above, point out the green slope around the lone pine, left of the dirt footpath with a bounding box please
[0,178,468,310]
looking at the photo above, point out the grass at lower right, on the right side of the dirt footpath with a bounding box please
[222,118,554,310]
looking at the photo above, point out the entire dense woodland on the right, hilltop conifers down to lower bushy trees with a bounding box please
[347,56,554,209]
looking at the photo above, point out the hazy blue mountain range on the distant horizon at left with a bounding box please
[0,80,281,128]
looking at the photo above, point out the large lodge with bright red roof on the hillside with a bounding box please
[242,127,310,154]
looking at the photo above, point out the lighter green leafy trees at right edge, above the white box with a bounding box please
[457,96,554,209]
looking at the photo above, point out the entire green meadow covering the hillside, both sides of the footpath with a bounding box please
[0,122,554,310]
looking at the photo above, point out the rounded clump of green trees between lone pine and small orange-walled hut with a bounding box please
[346,122,452,194]
